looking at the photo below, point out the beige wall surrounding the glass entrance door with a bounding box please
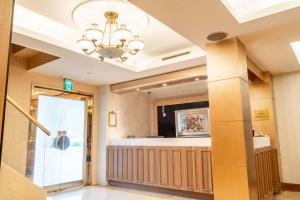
[3,59,99,184]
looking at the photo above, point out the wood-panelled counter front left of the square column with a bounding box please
[107,146,213,194]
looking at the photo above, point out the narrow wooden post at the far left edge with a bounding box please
[0,0,14,164]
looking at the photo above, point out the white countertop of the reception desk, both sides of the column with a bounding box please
[108,136,271,148]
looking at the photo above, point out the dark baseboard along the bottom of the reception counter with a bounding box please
[108,181,214,200]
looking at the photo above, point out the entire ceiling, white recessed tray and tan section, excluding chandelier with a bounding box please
[13,0,300,85]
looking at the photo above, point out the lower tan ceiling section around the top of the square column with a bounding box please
[130,0,300,74]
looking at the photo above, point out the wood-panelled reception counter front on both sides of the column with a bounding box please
[107,146,280,200]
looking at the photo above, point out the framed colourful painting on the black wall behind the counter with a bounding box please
[175,108,210,137]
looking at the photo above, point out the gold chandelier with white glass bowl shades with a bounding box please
[77,11,144,62]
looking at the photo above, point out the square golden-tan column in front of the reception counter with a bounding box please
[207,38,258,200]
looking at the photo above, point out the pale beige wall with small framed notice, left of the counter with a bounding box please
[98,85,151,185]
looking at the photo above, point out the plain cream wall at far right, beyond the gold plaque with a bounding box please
[273,72,300,184]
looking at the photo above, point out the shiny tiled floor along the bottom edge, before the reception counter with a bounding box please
[48,187,300,200]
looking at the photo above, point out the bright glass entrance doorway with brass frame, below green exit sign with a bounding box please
[26,86,92,192]
